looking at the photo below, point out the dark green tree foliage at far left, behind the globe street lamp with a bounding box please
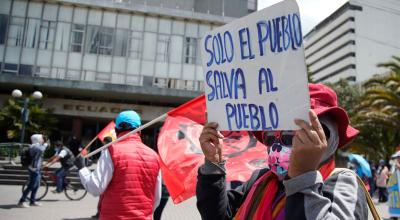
[0,99,57,142]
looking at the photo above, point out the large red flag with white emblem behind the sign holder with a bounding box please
[158,95,267,203]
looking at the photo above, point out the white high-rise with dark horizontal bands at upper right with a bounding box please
[304,0,400,82]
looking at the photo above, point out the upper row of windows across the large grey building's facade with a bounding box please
[0,14,200,64]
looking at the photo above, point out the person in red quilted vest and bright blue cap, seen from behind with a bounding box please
[75,110,161,220]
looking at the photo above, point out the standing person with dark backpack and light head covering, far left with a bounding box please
[18,134,48,208]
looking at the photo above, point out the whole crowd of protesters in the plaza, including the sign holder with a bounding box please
[18,84,400,220]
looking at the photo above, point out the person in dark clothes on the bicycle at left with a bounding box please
[45,141,75,193]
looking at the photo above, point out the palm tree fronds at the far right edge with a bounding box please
[353,57,400,160]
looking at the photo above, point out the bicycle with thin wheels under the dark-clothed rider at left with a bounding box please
[22,168,87,201]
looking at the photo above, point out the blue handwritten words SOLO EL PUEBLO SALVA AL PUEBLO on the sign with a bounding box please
[204,13,302,130]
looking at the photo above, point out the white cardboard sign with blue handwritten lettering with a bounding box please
[200,0,310,131]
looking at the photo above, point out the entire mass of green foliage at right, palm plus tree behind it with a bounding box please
[326,57,400,161]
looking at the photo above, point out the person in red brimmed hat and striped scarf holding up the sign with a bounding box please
[196,84,368,220]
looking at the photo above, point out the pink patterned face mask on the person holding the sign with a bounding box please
[263,131,294,179]
